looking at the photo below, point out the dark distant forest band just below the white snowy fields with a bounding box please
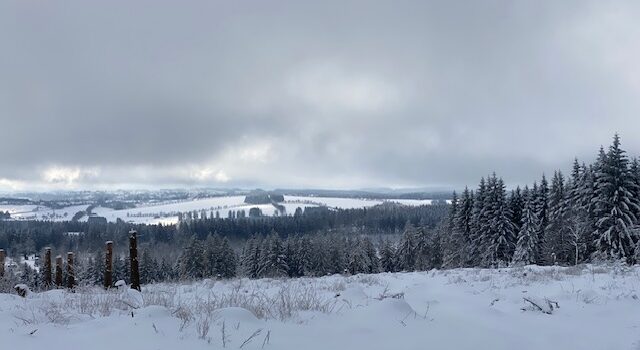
[0,204,448,256]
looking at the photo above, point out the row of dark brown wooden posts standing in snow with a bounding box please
[0,230,140,290]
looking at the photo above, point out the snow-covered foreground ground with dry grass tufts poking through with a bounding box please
[0,265,640,350]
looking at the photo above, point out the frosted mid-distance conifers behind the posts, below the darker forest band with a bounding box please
[10,223,442,290]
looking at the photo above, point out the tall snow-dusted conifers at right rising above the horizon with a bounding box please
[443,135,640,267]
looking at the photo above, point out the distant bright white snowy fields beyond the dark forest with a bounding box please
[0,196,432,224]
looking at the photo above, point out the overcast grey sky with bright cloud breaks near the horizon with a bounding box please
[0,0,640,191]
